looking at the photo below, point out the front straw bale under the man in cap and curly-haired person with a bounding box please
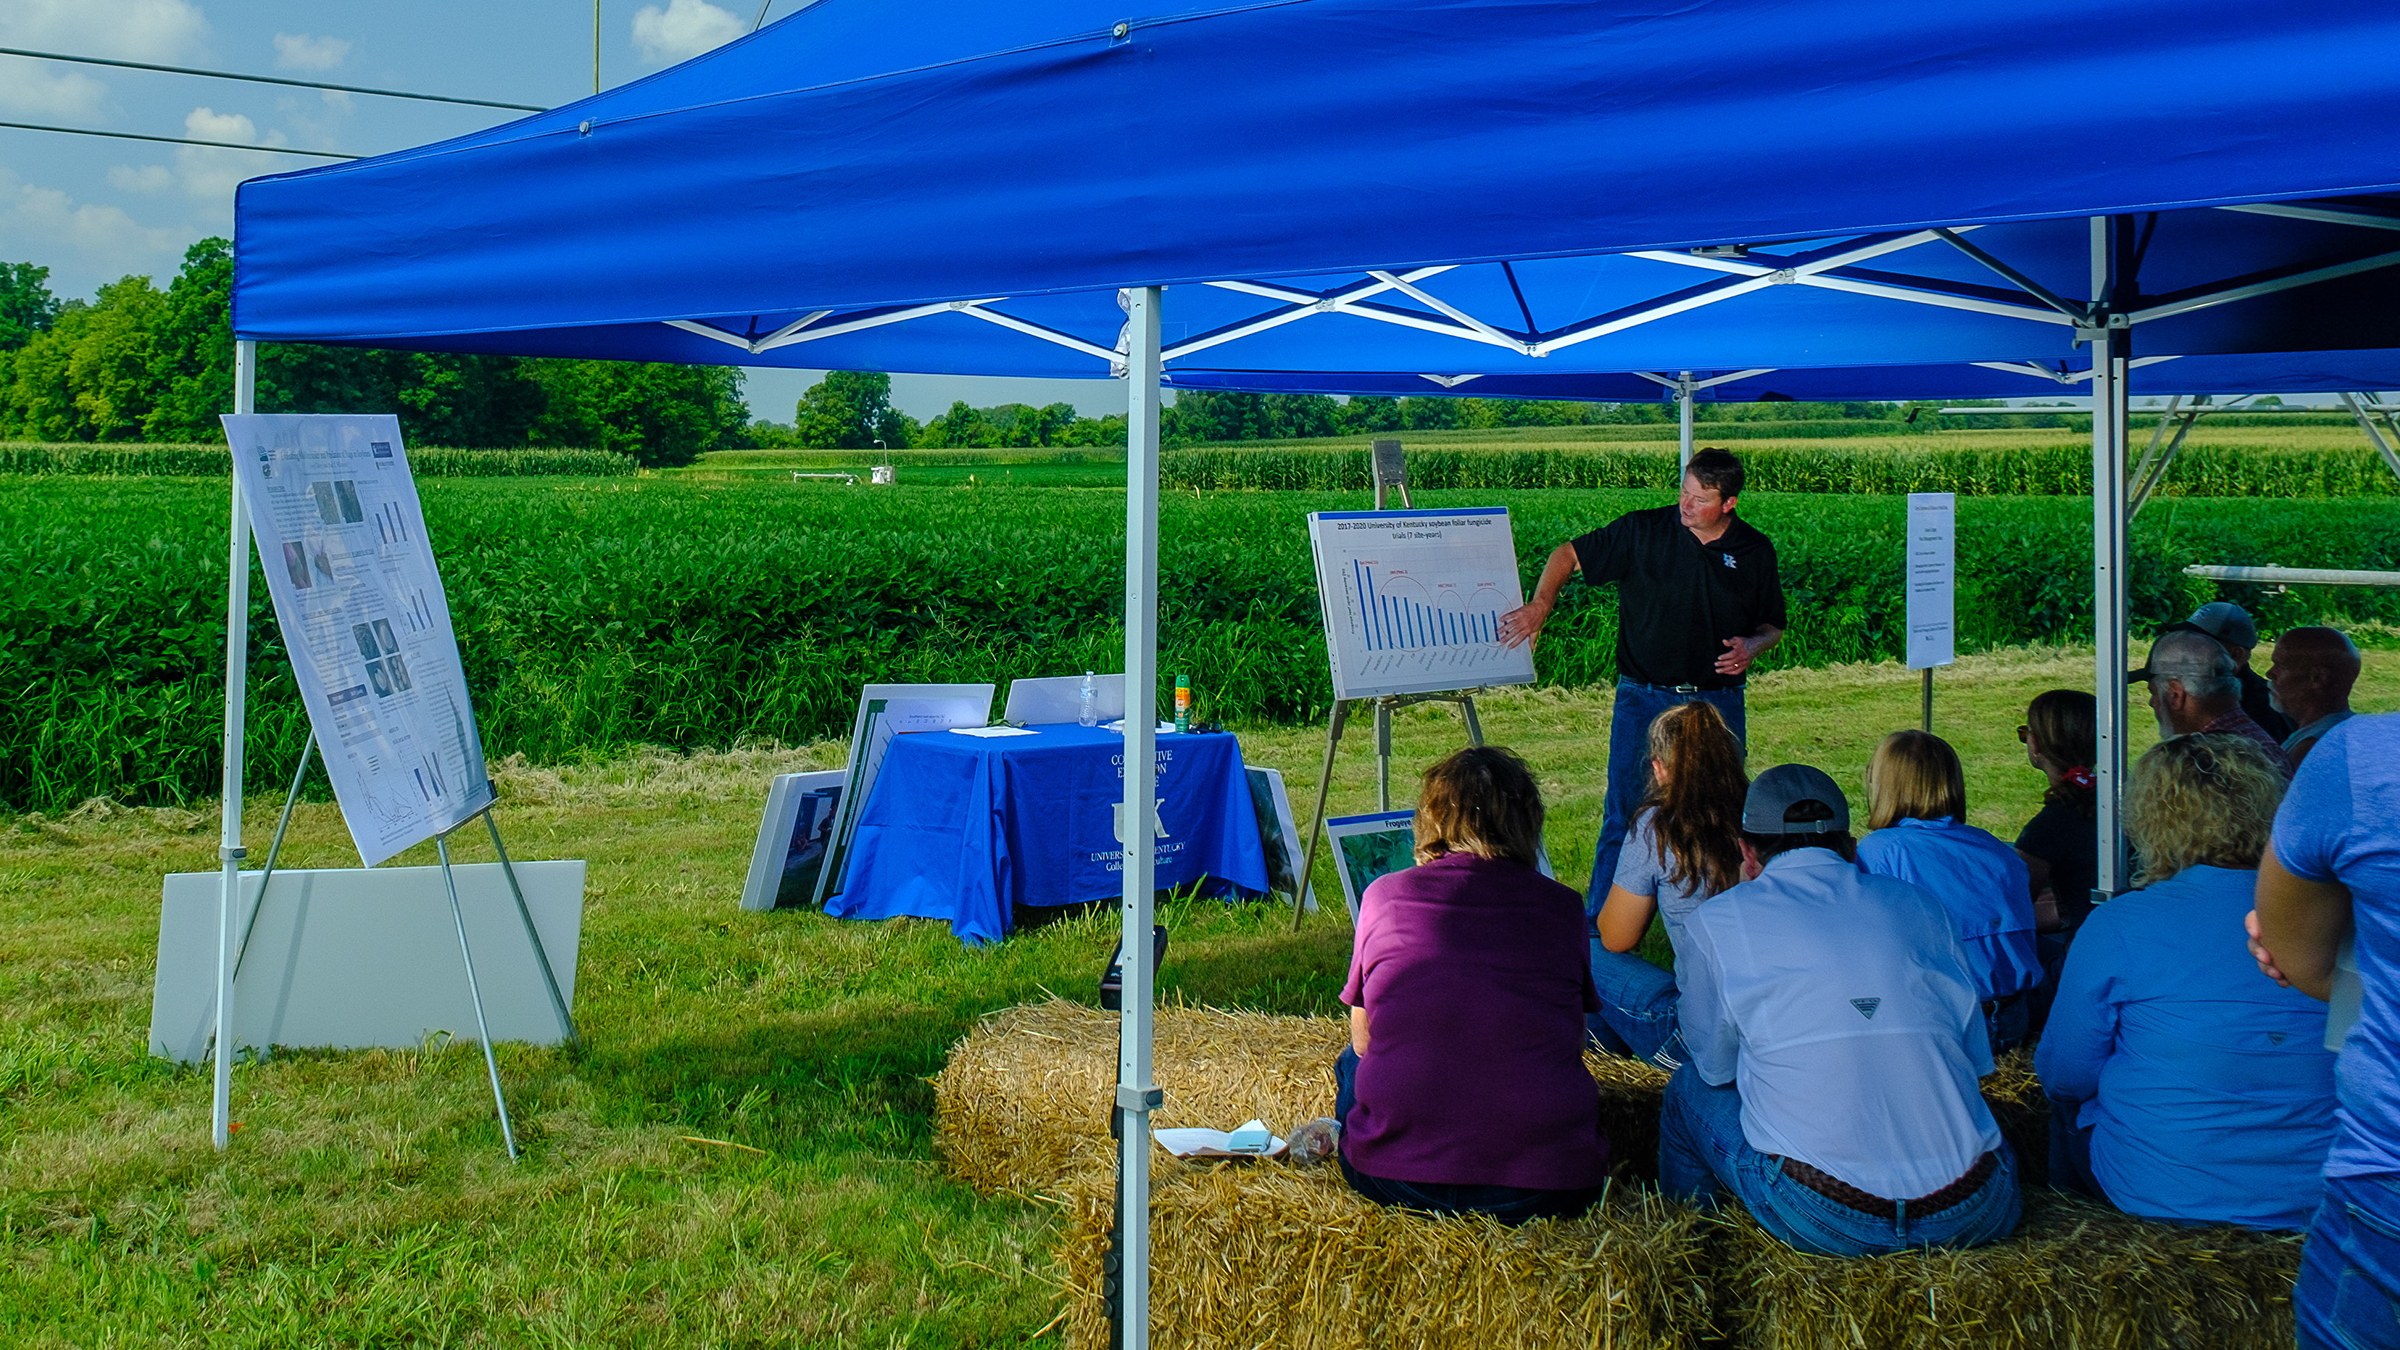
[1711,1187,2299,1350]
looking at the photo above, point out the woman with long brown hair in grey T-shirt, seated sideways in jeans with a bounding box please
[1591,704,1750,1069]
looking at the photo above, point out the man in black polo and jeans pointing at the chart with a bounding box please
[1500,449,1786,915]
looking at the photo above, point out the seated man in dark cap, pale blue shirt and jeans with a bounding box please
[1658,764,2021,1256]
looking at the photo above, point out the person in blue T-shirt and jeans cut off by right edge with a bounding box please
[2251,713,2400,1348]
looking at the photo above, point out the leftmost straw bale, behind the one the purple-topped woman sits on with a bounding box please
[934,999,1349,1194]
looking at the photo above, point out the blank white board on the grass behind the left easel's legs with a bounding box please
[149,862,583,1064]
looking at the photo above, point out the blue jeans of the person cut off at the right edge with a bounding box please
[2292,1175,2400,1350]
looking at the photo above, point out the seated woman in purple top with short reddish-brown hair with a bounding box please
[1334,747,1608,1223]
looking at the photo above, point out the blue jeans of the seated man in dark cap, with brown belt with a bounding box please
[1658,1064,2021,1256]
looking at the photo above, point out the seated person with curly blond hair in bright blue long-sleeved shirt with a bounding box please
[2033,735,2333,1227]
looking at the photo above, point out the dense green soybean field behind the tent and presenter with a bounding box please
[14,471,2400,812]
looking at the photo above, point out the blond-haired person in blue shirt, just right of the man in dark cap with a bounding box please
[1858,730,2042,1055]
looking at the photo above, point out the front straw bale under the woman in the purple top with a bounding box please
[1061,1158,1709,1350]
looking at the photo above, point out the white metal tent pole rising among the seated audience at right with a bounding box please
[2081,216,2131,896]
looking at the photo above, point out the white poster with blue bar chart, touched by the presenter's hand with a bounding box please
[1308,507,1534,699]
